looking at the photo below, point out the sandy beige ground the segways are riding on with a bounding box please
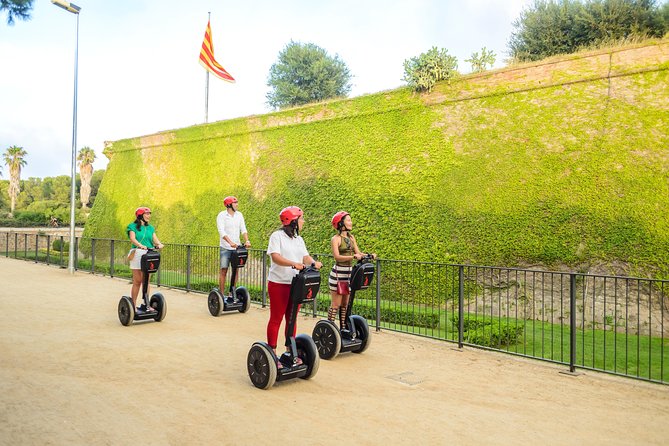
[0,258,669,445]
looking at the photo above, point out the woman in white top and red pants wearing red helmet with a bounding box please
[267,206,323,368]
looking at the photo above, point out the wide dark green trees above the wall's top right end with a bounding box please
[507,0,669,61]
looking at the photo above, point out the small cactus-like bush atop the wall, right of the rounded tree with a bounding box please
[402,46,458,91]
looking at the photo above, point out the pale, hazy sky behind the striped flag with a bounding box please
[0,0,532,179]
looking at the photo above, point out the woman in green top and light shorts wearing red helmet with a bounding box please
[126,207,163,313]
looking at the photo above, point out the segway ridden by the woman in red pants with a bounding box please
[246,265,321,389]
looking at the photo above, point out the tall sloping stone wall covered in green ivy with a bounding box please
[85,39,669,276]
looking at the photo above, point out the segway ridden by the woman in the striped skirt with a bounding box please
[311,254,374,360]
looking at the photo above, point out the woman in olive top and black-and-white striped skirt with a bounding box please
[328,211,362,328]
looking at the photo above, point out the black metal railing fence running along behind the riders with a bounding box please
[0,232,669,384]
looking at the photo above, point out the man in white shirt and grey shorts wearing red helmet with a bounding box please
[216,196,251,295]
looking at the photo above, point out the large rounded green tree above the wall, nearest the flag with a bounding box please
[267,41,351,108]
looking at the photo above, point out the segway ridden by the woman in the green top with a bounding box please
[118,249,167,327]
